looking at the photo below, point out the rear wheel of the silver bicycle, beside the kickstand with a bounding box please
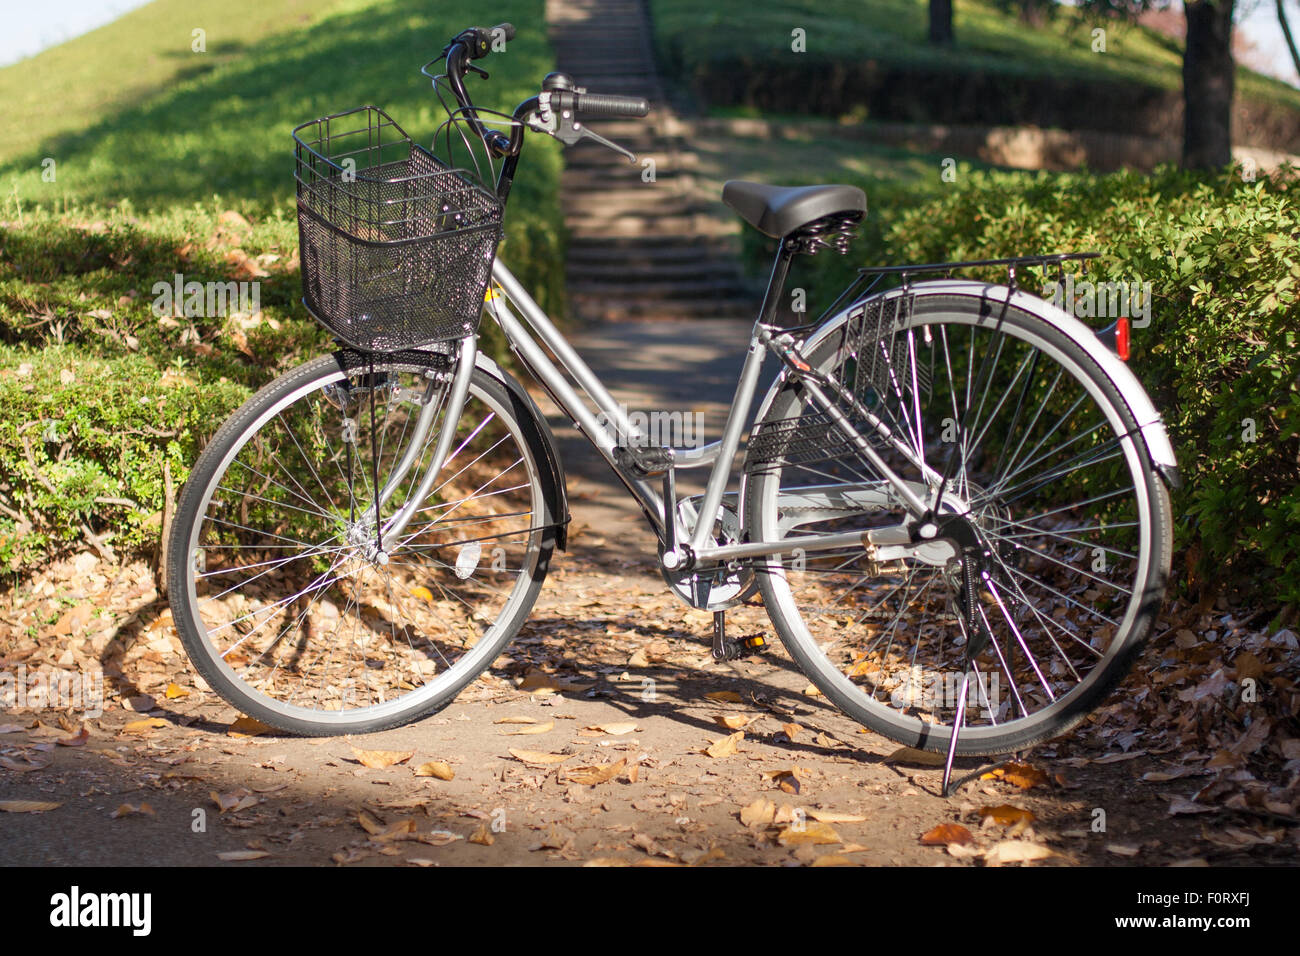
[746,293,1173,754]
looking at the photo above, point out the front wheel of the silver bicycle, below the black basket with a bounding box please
[168,354,555,735]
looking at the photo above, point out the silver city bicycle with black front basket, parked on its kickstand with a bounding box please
[168,23,1179,792]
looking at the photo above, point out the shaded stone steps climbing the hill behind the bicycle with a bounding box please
[546,0,759,321]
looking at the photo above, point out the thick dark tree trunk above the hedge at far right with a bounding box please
[1183,0,1235,169]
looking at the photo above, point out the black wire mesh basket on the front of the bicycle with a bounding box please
[294,107,502,351]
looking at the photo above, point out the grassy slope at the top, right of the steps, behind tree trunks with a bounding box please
[650,0,1300,108]
